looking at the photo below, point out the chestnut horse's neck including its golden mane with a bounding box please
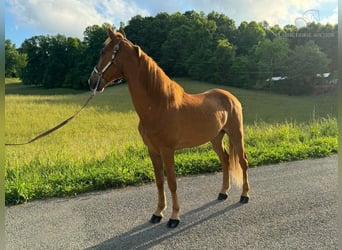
[127,53,184,119]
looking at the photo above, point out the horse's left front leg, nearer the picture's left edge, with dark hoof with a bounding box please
[149,151,166,223]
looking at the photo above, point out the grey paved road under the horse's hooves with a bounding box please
[6,156,338,250]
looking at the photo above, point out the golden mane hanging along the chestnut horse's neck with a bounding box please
[139,51,184,109]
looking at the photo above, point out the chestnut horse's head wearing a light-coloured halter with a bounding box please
[88,29,127,94]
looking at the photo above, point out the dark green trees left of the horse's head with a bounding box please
[5,24,110,89]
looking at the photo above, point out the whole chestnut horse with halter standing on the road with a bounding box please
[88,29,249,228]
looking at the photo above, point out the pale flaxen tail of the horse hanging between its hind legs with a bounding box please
[229,138,243,187]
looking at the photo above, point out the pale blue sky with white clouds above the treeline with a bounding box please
[5,0,338,47]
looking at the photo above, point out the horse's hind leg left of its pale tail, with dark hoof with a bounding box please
[211,131,229,200]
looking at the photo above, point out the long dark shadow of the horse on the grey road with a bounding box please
[87,200,242,250]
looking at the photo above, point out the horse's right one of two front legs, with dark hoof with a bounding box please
[161,149,180,228]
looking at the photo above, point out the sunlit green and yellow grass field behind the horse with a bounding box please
[5,79,338,204]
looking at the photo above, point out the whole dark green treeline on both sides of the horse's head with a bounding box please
[6,11,338,94]
